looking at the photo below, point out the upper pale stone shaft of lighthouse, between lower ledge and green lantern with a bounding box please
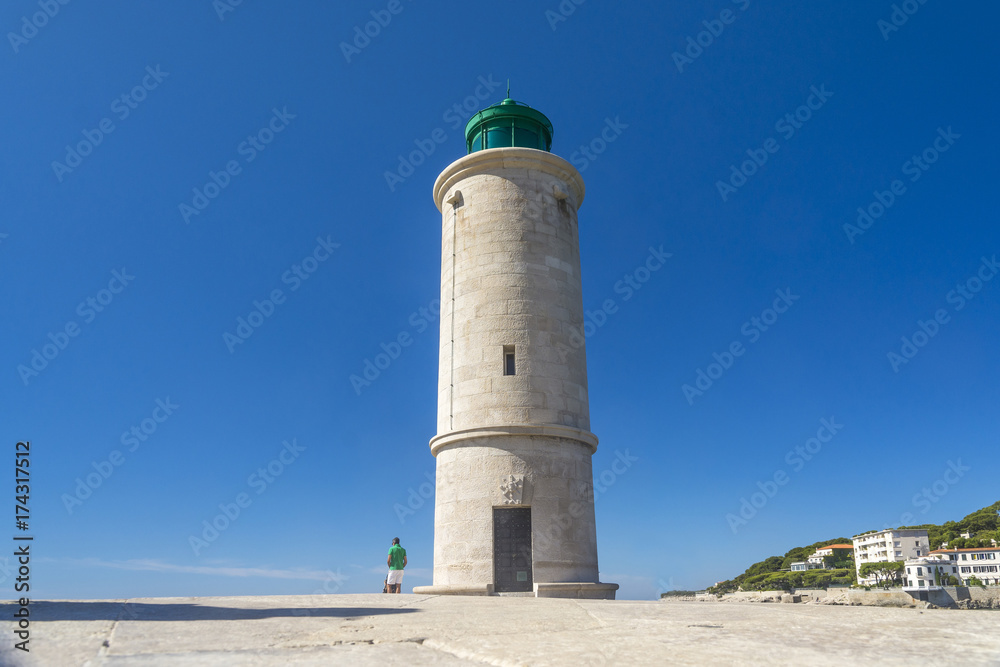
[435,148,590,434]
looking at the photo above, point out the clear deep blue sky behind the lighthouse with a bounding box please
[0,0,1000,598]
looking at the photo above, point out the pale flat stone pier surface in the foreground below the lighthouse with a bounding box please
[0,594,1000,667]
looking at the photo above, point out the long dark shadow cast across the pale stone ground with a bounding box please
[0,600,420,621]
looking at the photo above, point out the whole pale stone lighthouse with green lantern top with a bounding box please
[414,99,618,599]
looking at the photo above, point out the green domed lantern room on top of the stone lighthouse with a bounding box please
[465,97,552,153]
